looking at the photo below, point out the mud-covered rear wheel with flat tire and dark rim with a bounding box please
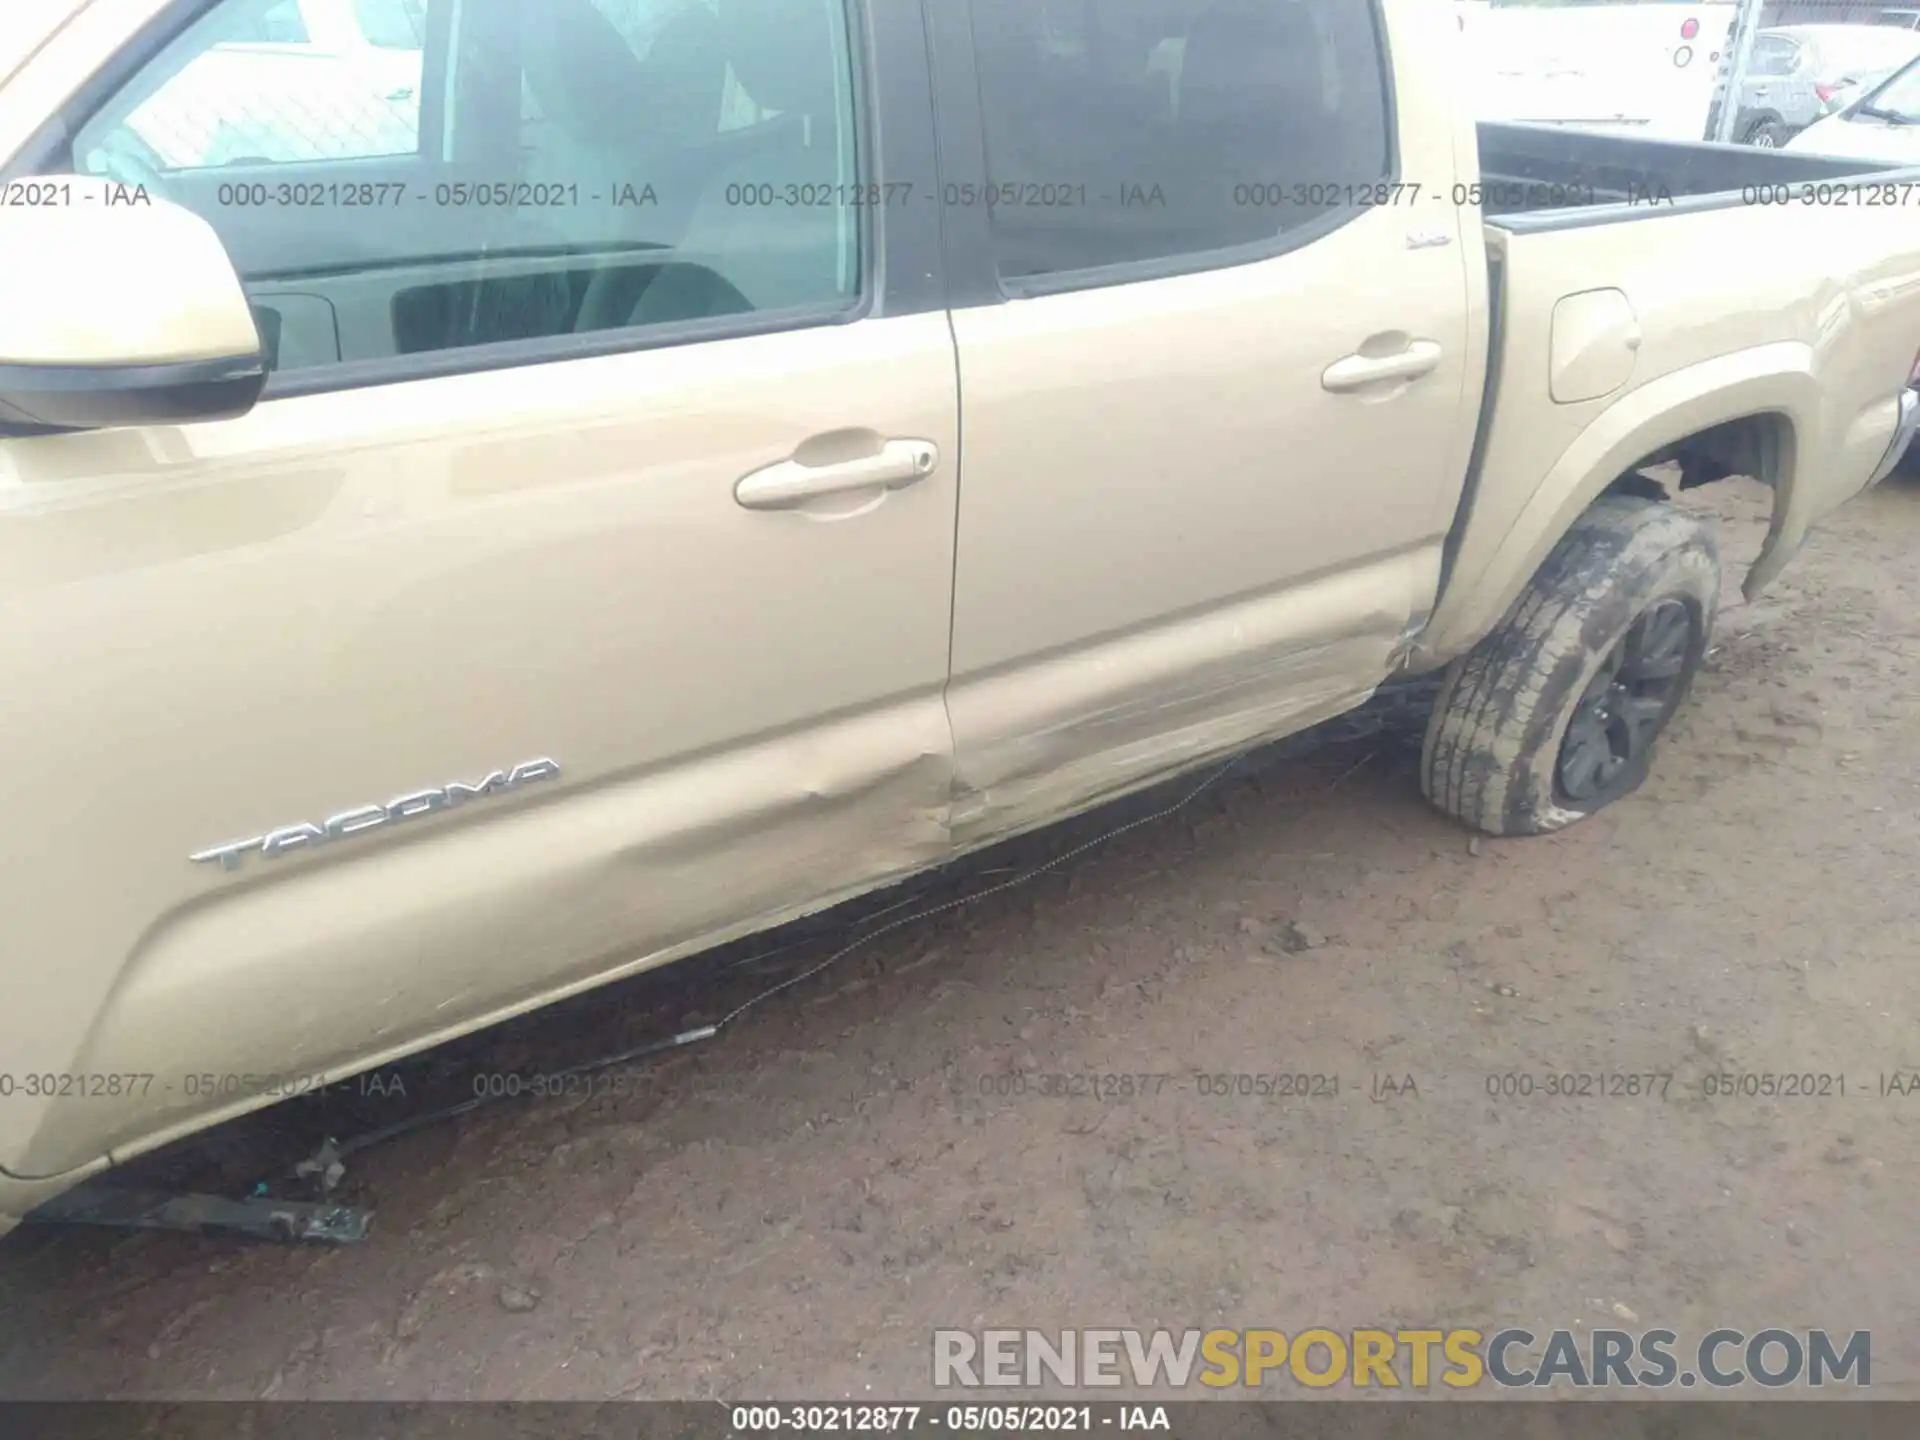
[1421,495,1720,835]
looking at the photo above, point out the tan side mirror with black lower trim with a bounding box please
[0,175,267,434]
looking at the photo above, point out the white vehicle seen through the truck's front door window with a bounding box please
[94,0,426,171]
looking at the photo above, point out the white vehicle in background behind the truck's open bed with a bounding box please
[1455,0,1740,140]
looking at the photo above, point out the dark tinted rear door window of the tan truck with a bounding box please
[967,0,1392,278]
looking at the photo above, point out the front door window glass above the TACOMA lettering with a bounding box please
[73,0,868,378]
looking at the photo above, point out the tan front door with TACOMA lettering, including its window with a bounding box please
[0,0,958,1175]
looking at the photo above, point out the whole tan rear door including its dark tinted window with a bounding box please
[937,0,1484,843]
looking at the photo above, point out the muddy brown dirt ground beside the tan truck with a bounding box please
[0,482,1920,1400]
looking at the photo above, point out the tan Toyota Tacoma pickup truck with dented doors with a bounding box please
[0,0,1920,1227]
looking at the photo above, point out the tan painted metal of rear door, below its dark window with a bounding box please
[948,19,1488,841]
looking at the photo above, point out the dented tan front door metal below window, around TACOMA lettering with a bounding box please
[0,315,958,1198]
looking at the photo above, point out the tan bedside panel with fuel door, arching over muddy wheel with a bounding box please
[1413,138,1920,668]
